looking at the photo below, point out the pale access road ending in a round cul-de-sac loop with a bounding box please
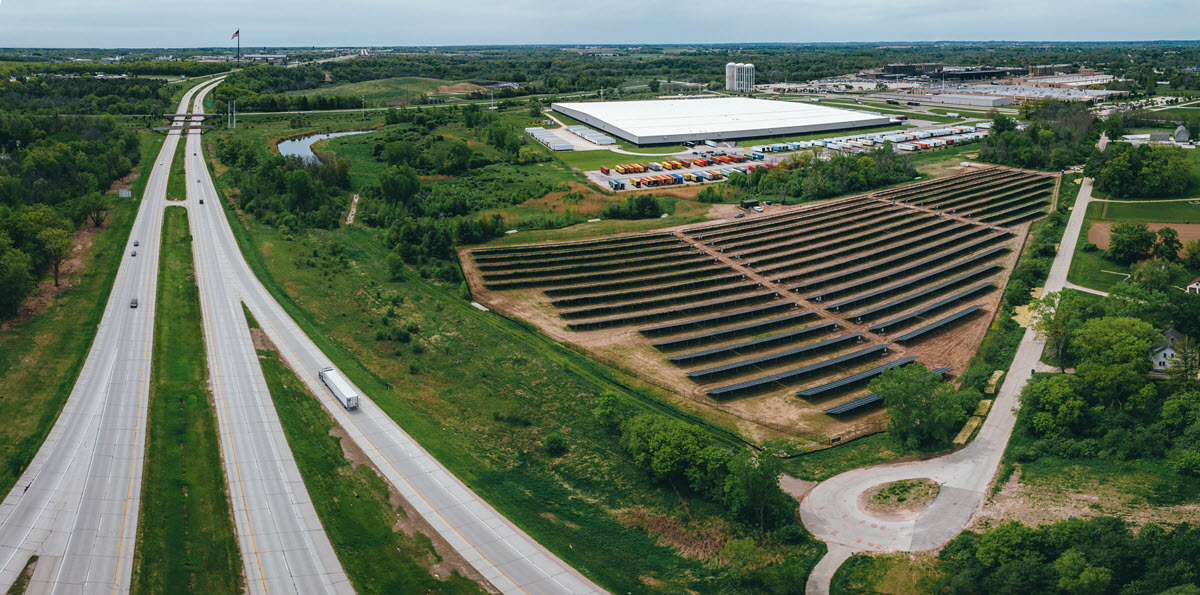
[800,167,1103,594]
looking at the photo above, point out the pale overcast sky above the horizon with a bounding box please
[0,0,1200,48]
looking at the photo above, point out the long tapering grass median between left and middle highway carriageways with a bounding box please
[130,206,244,594]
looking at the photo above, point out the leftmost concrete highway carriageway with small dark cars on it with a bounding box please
[0,79,223,593]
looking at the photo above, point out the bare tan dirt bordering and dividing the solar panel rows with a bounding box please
[460,190,1028,444]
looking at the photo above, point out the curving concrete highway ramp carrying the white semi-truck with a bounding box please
[187,77,602,594]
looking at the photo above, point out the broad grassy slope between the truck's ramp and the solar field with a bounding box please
[204,140,823,593]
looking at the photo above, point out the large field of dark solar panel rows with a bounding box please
[470,168,1054,413]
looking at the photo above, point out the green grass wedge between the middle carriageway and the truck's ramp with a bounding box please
[258,350,485,594]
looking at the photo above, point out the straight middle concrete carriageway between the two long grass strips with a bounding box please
[185,83,354,594]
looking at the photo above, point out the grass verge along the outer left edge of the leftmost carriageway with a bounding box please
[0,132,162,497]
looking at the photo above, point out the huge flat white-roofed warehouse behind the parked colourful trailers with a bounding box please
[551,97,890,145]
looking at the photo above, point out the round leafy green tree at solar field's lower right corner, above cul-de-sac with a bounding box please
[870,363,966,449]
